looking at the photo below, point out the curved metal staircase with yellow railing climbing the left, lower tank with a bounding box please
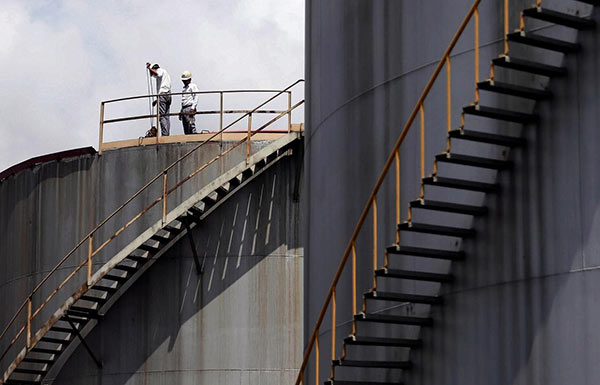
[0,81,303,385]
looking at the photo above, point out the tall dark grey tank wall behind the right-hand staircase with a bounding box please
[303,0,599,384]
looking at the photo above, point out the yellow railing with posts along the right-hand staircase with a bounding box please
[295,0,516,385]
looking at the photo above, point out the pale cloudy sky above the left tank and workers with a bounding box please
[0,0,304,171]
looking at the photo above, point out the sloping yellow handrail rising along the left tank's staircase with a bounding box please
[0,79,304,370]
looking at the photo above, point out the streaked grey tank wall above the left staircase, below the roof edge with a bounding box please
[0,142,282,369]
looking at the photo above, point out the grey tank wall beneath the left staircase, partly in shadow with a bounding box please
[54,153,302,384]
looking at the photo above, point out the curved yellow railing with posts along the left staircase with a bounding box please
[0,79,304,381]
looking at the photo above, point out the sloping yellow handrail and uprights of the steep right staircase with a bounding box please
[295,0,481,385]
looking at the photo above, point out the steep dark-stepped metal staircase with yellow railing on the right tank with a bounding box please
[296,0,600,385]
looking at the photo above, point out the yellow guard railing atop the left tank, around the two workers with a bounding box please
[98,89,292,154]
